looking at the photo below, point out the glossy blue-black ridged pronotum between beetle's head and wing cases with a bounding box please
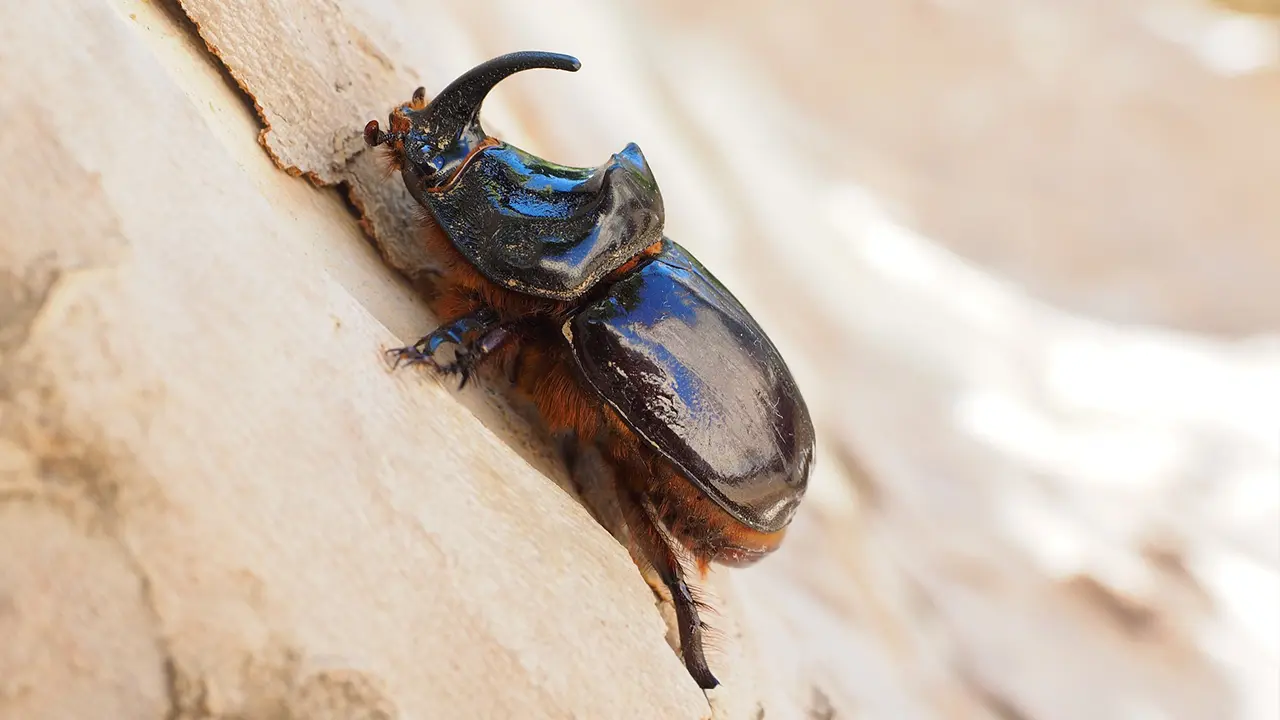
[411,142,663,300]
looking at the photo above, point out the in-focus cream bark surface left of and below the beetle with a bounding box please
[0,3,708,719]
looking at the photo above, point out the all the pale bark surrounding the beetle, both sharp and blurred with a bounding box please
[0,0,1280,720]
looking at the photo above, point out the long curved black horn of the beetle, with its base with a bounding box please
[404,50,582,184]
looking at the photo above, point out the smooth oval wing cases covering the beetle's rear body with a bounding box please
[564,240,814,533]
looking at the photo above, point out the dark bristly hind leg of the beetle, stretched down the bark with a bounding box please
[618,484,719,691]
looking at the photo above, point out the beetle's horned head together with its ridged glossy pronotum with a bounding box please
[389,51,663,300]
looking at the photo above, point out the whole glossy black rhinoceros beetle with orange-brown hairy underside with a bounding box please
[365,51,814,688]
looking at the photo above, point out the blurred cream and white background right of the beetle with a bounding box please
[430,0,1280,720]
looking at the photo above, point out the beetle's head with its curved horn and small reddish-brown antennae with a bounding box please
[365,50,581,197]
